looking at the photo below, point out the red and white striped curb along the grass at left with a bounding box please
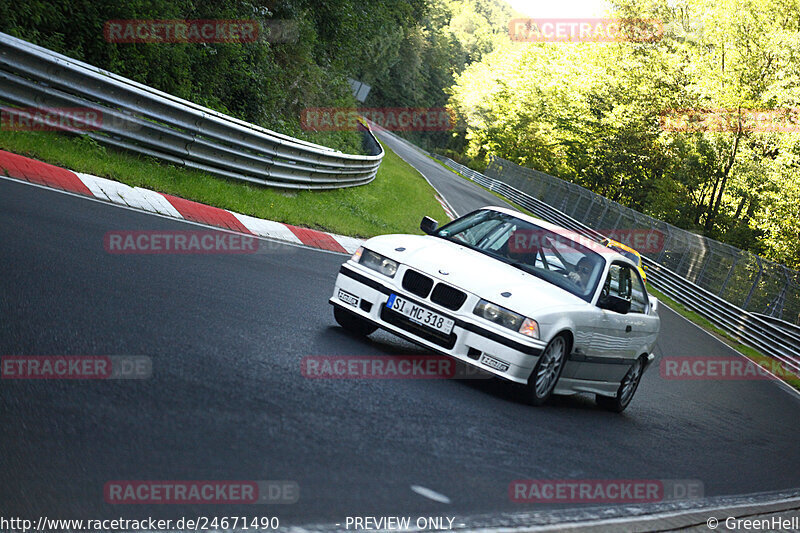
[0,150,363,254]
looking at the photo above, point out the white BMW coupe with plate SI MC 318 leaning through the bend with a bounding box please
[330,207,660,412]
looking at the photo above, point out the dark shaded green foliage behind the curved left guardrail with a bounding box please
[0,0,432,151]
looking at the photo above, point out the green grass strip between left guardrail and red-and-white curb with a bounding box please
[0,131,446,238]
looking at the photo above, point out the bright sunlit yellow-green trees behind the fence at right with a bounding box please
[451,0,800,267]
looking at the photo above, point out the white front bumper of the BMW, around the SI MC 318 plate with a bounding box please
[329,262,546,383]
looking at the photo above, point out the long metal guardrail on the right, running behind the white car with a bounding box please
[433,154,800,375]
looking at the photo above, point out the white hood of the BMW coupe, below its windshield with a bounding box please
[364,235,589,317]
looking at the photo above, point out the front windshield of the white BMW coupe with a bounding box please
[434,210,604,301]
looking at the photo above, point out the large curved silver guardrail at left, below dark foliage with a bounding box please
[0,33,383,189]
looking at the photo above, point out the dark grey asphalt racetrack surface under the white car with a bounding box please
[0,143,800,525]
